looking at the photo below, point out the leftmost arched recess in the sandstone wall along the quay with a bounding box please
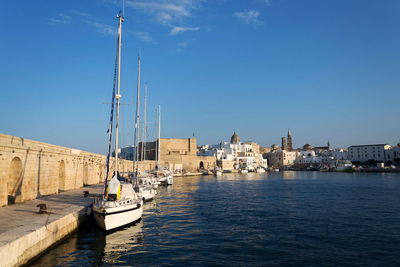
[7,157,22,205]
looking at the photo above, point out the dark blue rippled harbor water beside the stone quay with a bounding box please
[32,172,400,266]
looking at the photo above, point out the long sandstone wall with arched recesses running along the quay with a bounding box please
[0,134,139,206]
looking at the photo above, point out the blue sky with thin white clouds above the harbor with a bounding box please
[0,0,400,152]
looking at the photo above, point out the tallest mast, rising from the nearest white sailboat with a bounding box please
[115,14,124,175]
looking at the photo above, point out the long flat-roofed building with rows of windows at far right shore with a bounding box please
[348,144,393,162]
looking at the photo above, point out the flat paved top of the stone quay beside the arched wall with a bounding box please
[0,184,103,247]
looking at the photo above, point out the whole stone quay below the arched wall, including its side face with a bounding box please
[0,185,103,266]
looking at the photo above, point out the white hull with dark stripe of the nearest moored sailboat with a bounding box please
[93,204,143,231]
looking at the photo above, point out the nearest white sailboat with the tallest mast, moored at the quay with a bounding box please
[93,14,143,231]
